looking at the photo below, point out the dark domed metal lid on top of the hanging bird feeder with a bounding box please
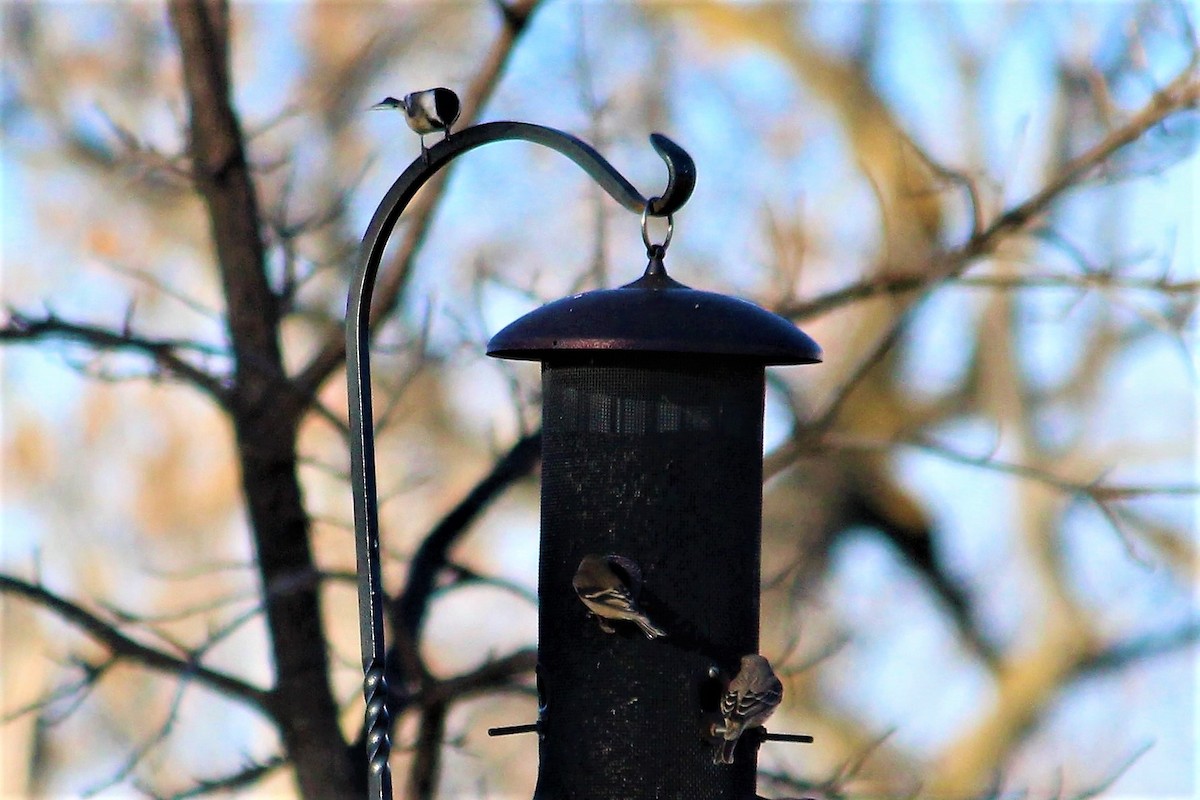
[487,257,821,366]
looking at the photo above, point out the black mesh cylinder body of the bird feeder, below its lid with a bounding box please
[535,356,763,800]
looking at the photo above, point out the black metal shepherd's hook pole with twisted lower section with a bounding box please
[346,122,696,800]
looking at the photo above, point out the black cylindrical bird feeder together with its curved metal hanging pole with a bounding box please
[347,112,821,800]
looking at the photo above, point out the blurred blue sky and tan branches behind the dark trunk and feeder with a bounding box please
[0,0,1200,798]
